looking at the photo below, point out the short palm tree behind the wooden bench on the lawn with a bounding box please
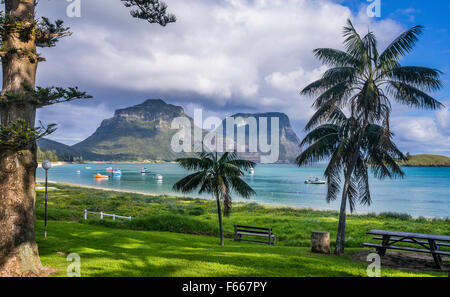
[173,152,255,246]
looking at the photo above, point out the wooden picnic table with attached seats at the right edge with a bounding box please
[363,229,450,270]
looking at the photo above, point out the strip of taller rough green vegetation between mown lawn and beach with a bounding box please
[36,184,450,248]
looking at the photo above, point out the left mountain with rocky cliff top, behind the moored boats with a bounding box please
[73,99,197,161]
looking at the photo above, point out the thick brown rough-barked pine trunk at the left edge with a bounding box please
[0,0,42,276]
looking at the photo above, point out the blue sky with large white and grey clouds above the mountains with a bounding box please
[18,0,450,156]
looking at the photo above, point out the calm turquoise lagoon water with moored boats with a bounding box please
[37,163,450,218]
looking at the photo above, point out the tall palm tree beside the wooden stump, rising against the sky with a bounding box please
[297,20,443,254]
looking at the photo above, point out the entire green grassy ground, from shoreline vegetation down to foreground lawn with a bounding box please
[36,184,450,276]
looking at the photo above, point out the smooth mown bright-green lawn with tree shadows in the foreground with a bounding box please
[36,220,446,277]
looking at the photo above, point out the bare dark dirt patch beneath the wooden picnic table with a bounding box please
[350,250,449,272]
